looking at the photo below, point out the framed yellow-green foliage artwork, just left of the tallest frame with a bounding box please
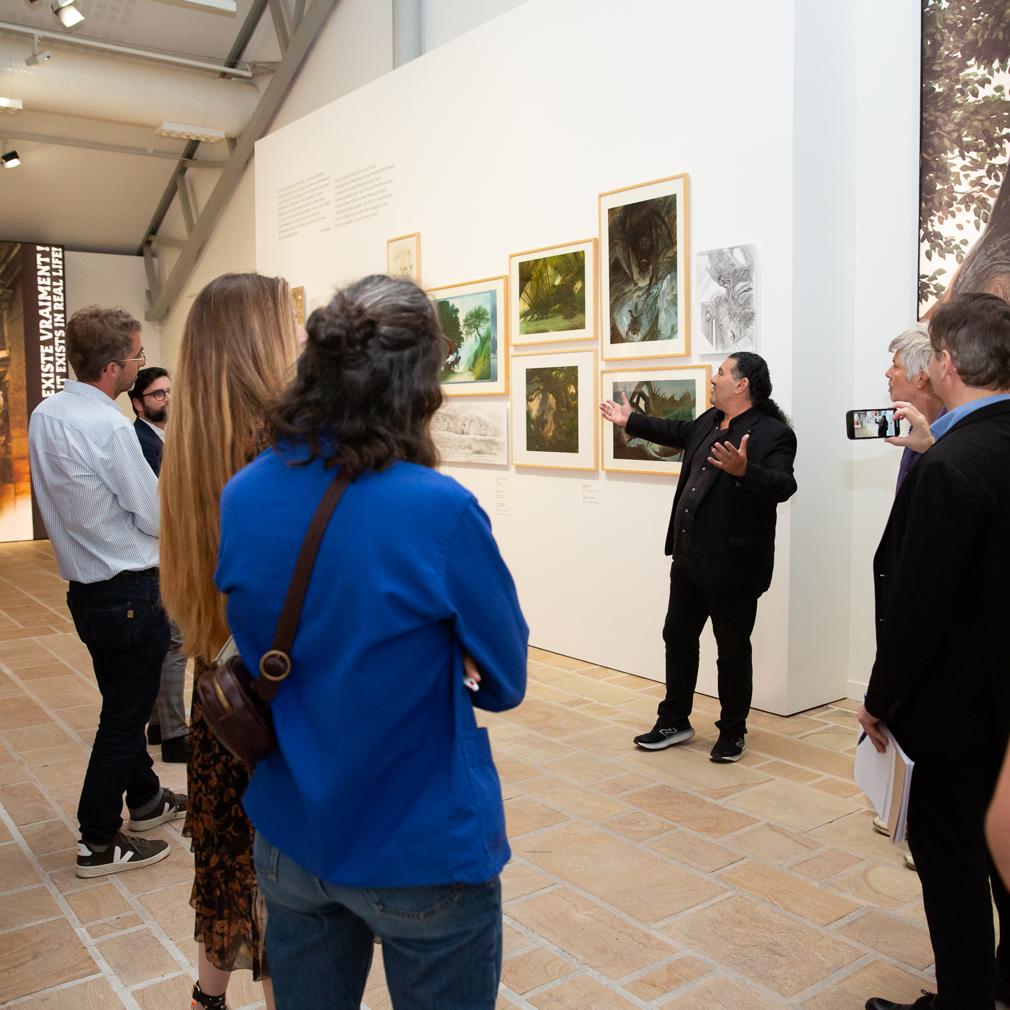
[509,238,597,346]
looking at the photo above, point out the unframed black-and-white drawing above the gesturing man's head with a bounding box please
[694,245,758,355]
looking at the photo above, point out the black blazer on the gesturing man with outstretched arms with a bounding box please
[627,407,796,596]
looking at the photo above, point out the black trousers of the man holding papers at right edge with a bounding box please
[908,740,1010,1010]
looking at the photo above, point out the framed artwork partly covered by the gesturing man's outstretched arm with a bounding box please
[600,365,712,477]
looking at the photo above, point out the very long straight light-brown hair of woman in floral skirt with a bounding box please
[160,274,298,660]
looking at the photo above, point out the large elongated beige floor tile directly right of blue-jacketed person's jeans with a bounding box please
[509,888,675,979]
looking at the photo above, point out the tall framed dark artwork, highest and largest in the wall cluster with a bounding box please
[600,175,691,359]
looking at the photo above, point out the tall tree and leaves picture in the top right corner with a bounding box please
[918,0,1010,313]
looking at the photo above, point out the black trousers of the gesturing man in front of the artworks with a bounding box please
[659,565,758,734]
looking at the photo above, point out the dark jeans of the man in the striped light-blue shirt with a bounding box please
[67,569,169,844]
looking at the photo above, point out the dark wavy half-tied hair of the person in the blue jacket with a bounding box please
[269,274,448,477]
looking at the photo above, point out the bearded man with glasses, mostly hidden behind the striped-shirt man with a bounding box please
[129,366,189,765]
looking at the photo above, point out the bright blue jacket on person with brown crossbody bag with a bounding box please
[216,449,527,888]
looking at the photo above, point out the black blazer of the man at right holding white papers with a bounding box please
[866,401,1010,760]
